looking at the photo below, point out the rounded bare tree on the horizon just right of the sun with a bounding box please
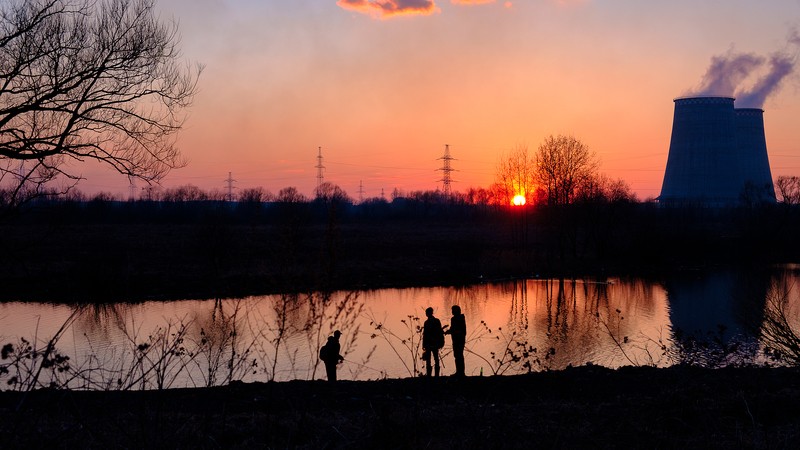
[535,135,598,205]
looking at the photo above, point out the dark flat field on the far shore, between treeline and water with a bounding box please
[0,205,800,302]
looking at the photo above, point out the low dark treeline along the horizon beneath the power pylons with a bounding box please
[0,183,637,223]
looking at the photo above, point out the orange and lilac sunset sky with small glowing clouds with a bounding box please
[73,0,800,200]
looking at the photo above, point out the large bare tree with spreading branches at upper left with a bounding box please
[0,0,202,207]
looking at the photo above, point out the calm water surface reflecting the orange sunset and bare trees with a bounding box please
[0,266,800,389]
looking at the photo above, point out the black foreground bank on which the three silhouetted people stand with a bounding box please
[0,367,800,448]
